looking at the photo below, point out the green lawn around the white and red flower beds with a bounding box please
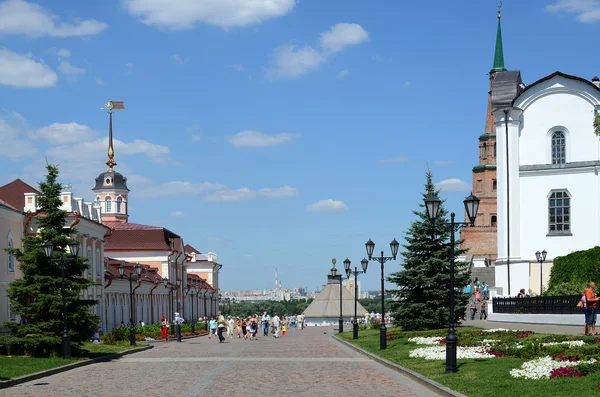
[338,328,600,397]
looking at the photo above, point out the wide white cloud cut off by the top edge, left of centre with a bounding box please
[124,0,296,30]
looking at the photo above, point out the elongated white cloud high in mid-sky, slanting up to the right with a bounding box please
[266,23,369,80]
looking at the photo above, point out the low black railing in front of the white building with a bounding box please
[492,295,582,314]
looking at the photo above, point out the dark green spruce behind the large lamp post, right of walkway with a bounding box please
[388,172,470,331]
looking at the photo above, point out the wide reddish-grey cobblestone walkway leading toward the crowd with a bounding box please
[0,327,446,397]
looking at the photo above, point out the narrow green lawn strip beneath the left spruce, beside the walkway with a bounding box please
[0,342,146,381]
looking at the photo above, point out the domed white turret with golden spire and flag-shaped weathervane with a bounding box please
[92,101,129,222]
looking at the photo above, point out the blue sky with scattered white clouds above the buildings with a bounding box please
[0,0,600,290]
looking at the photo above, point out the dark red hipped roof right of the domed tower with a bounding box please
[104,222,179,251]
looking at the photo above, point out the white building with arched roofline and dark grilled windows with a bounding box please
[492,71,600,296]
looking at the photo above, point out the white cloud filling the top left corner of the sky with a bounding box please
[0,0,108,37]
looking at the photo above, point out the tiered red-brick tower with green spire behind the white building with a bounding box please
[460,9,506,267]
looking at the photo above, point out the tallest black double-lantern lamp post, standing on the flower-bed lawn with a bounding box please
[425,194,479,374]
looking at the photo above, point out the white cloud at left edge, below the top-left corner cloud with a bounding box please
[0,48,58,88]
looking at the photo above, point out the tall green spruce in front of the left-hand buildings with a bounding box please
[5,165,99,356]
